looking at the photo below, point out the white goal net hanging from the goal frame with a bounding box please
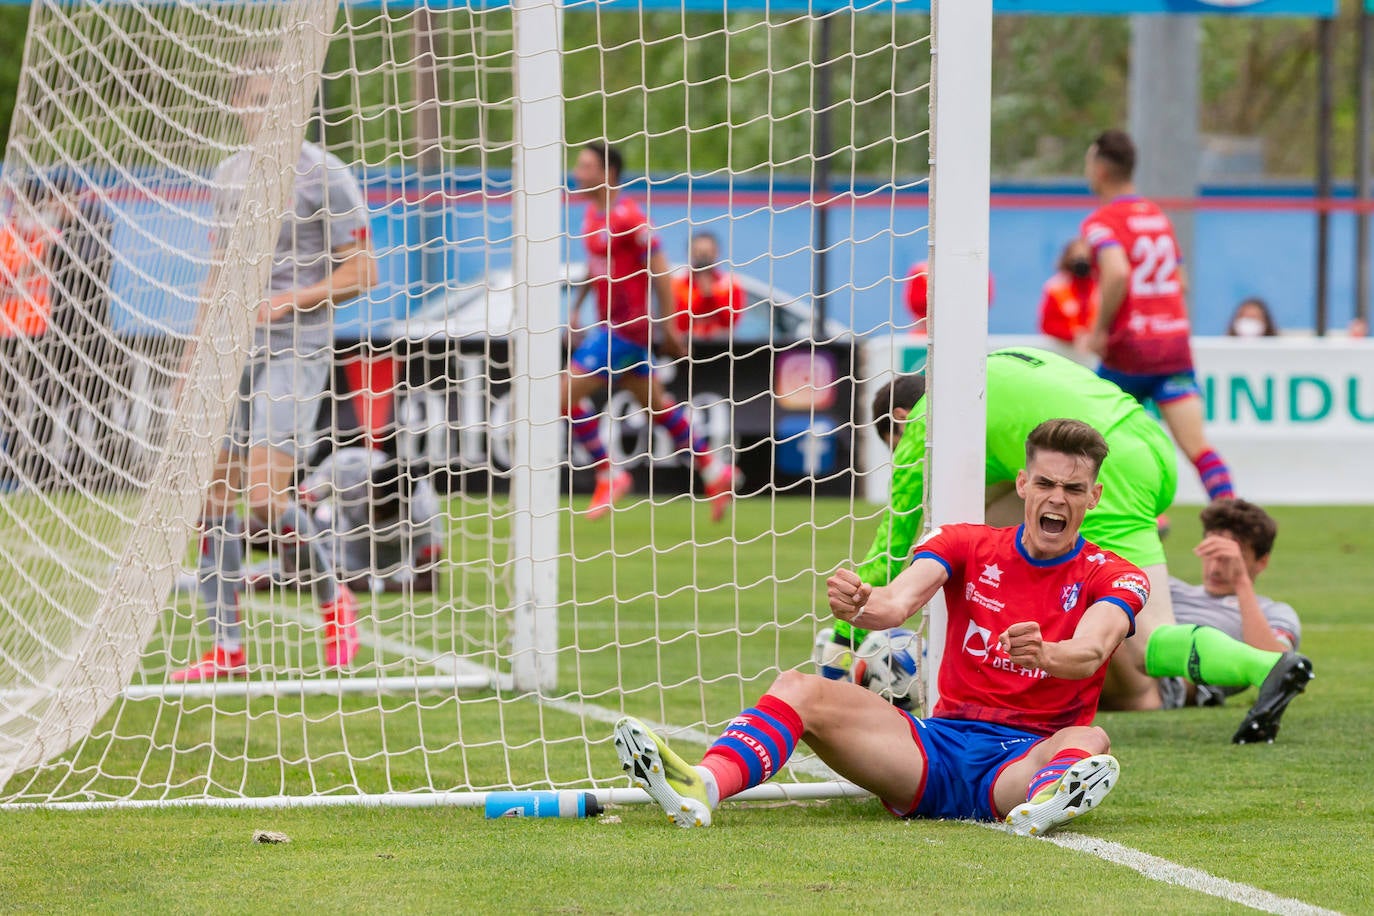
[0,0,987,805]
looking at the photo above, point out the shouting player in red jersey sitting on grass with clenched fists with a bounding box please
[616,419,1150,834]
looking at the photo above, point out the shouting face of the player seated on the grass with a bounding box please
[1017,449,1102,560]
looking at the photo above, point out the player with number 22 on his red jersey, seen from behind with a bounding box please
[1081,130,1235,500]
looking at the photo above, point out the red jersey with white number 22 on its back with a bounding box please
[1081,195,1193,375]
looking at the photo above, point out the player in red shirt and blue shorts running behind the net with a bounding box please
[562,143,738,522]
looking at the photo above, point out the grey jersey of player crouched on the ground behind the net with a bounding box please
[301,448,441,551]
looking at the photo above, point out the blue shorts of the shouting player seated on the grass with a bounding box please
[888,713,1044,821]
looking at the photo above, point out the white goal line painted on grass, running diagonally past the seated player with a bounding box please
[254,603,1341,916]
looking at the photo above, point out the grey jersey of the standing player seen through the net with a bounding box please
[214,143,368,352]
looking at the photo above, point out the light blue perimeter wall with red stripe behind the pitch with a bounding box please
[99,174,1370,338]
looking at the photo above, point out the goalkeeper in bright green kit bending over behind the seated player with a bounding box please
[815,347,1312,743]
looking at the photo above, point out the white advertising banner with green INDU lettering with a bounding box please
[859,336,1374,505]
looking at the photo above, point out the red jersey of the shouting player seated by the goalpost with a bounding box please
[915,525,1150,735]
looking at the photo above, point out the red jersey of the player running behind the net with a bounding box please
[583,195,658,346]
